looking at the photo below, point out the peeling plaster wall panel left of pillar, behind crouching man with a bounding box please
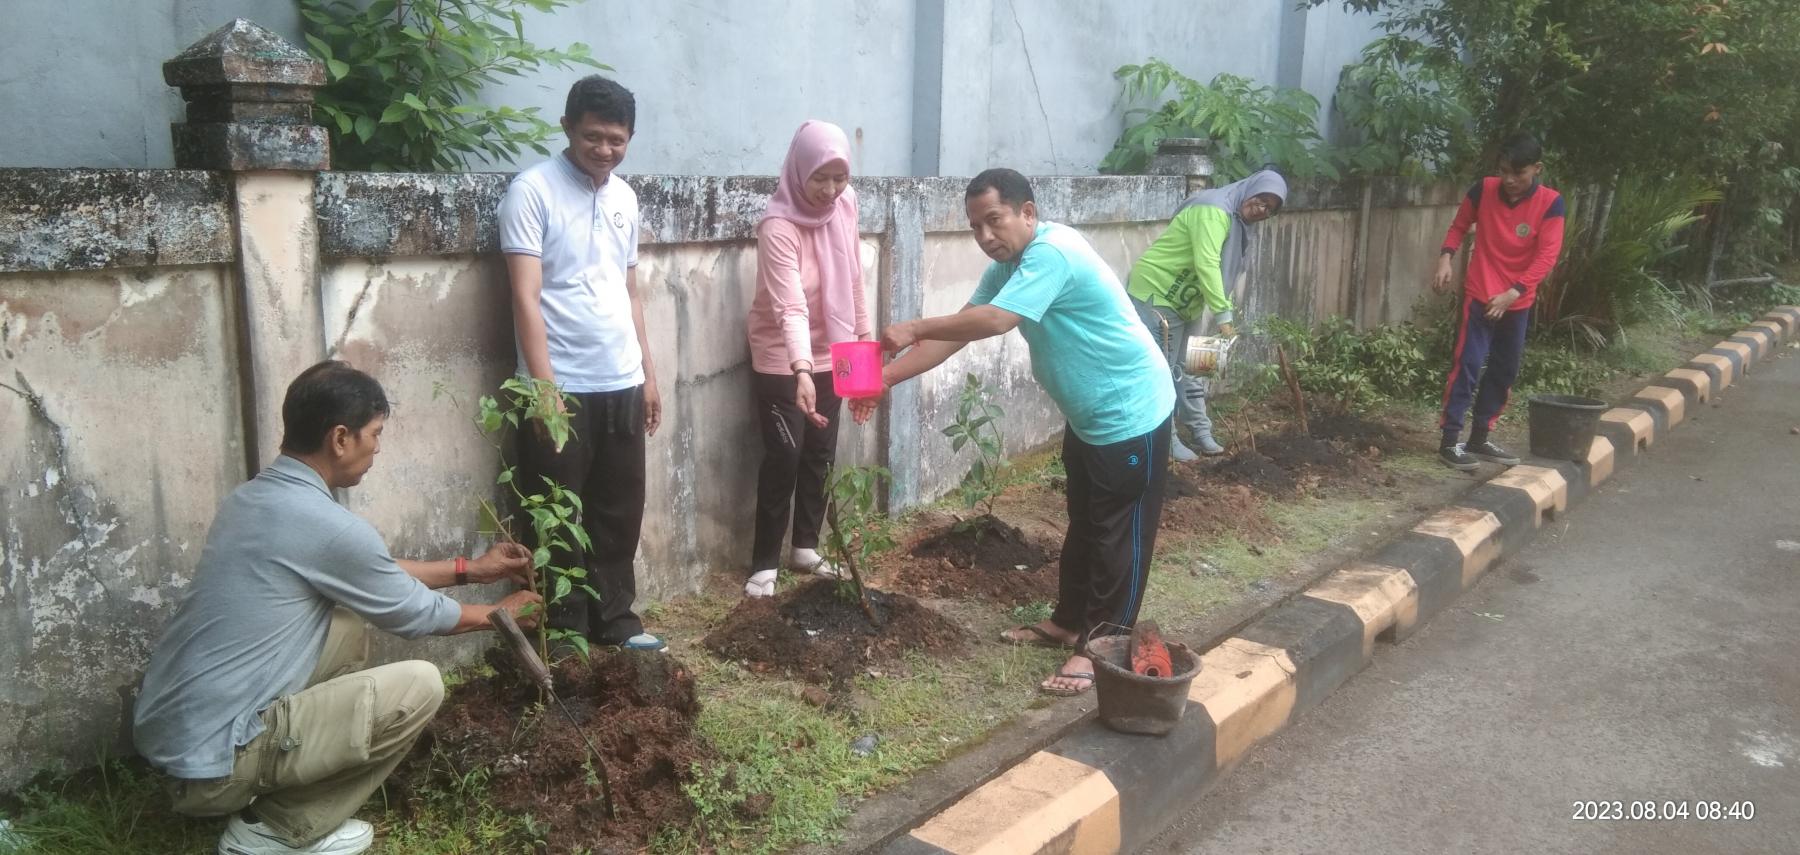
[0,266,245,787]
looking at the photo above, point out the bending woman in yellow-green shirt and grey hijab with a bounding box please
[1125,169,1287,461]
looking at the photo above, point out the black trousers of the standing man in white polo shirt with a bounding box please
[518,385,644,644]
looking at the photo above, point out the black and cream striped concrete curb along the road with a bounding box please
[871,306,1800,855]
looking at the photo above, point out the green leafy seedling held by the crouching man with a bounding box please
[434,376,599,662]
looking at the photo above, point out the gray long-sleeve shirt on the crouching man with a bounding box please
[131,455,461,779]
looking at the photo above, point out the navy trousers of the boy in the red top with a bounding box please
[1438,299,1532,445]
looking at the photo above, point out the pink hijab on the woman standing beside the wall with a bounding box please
[763,119,862,327]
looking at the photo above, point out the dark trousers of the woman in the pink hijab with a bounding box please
[751,371,841,572]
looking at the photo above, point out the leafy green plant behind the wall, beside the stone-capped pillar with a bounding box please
[299,0,607,171]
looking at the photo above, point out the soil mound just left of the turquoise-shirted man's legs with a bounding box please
[889,515,1058,605]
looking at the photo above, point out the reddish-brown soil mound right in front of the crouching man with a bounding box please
[391,650,713,853]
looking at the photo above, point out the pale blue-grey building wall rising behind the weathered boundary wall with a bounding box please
[0,0,1377,175]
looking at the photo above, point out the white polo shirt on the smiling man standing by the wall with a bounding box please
[500,153,644,392]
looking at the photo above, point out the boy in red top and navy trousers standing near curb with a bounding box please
[1431,133,1562,472]
